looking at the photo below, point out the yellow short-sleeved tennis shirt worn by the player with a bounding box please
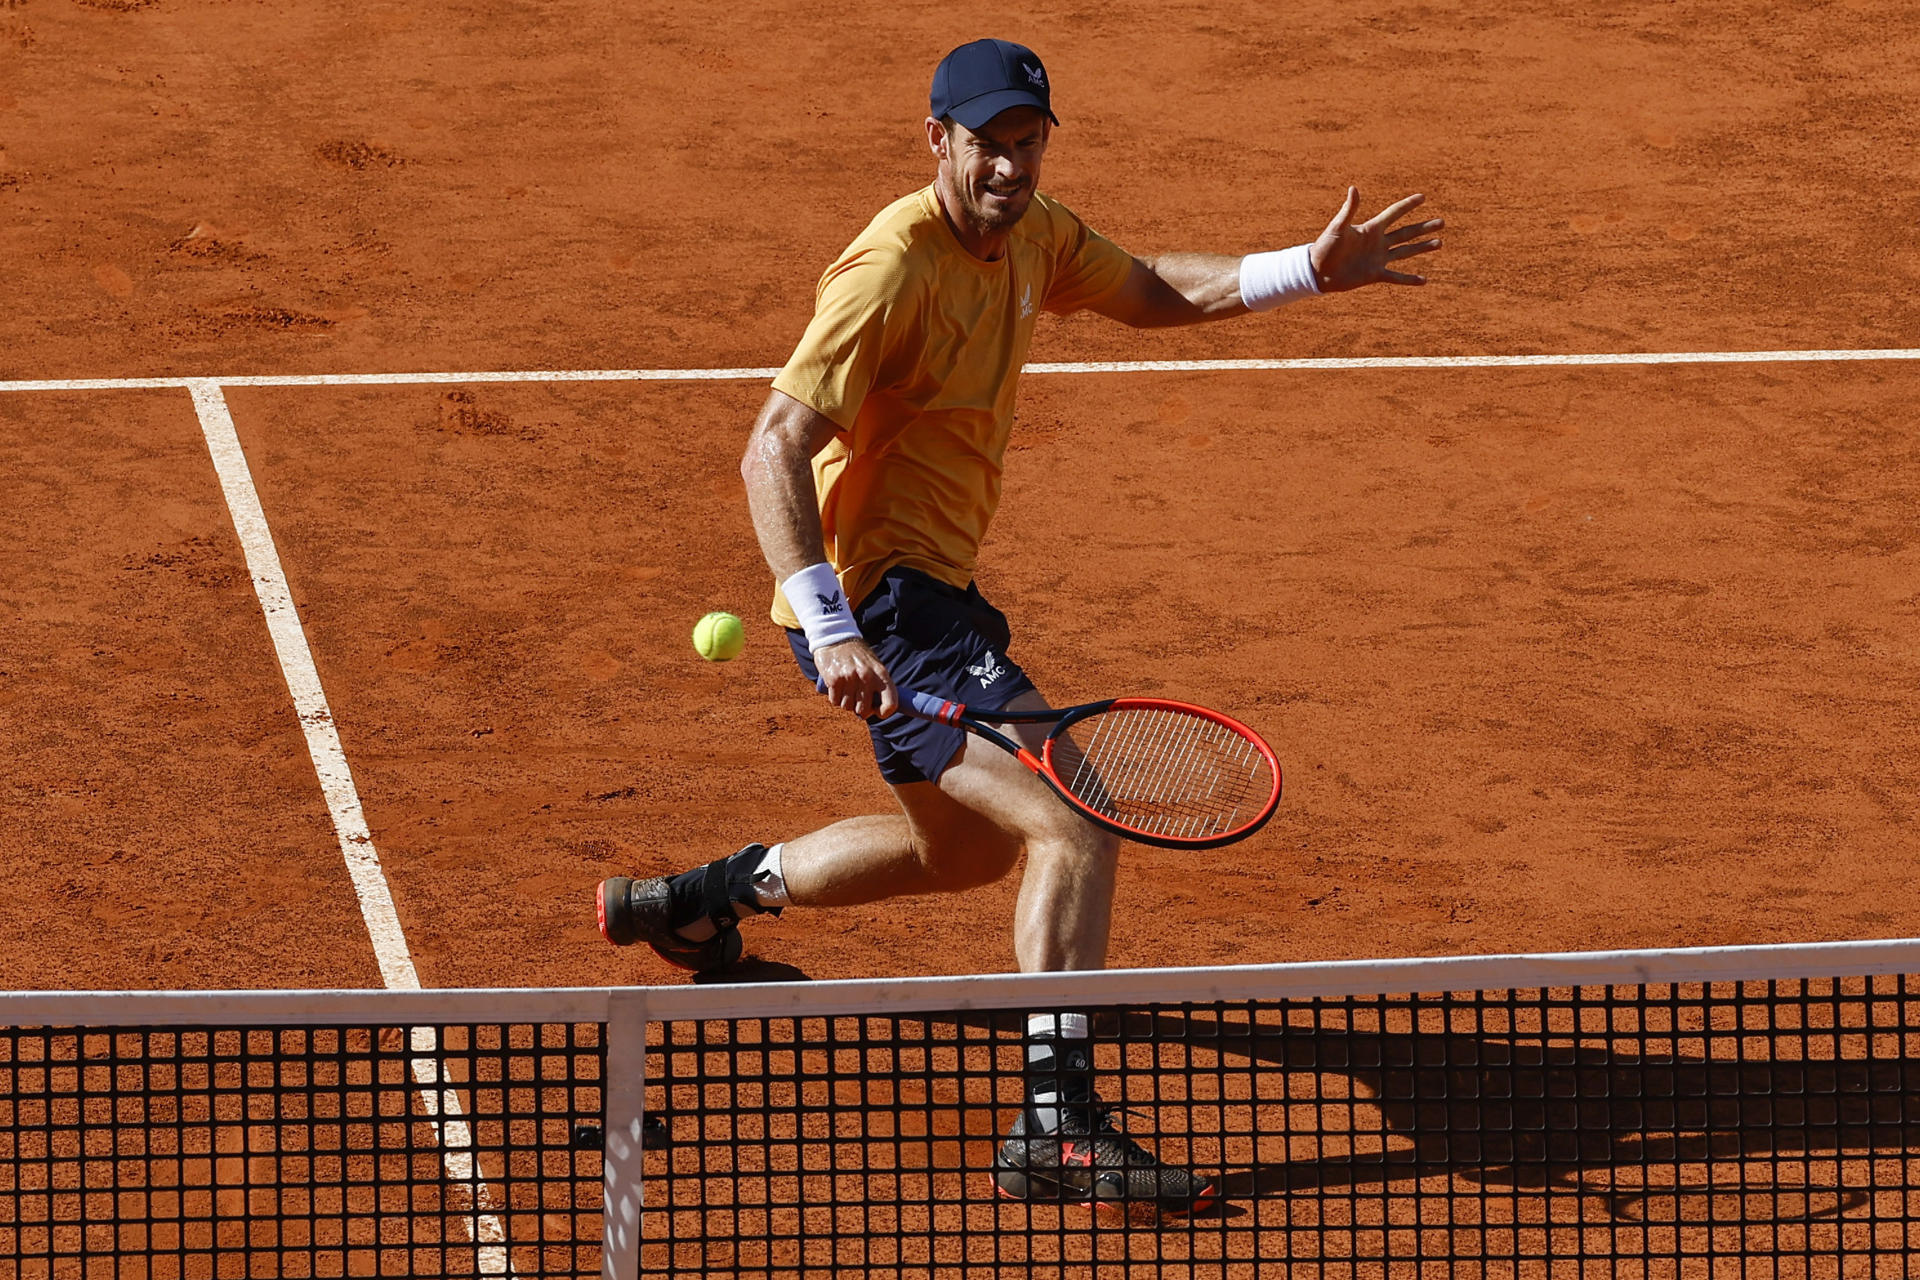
[772,186,1133,628]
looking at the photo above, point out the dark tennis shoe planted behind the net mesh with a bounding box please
[993,1103,1217,1222]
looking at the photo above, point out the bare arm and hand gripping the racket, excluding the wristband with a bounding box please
[739,391,899,716]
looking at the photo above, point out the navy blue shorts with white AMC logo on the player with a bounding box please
[787,568,1033,783]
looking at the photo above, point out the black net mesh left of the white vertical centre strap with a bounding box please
[0,1025,605,1280]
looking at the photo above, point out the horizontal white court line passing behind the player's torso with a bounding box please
[11,347,1920,391]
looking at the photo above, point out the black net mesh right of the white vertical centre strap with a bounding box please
[641,977,1920,1280]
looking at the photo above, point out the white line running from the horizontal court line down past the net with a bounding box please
[186,380,513,1276]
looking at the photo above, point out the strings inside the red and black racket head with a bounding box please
[1052,706,1273,841]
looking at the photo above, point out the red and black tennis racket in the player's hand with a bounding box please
[900,689,1281,848]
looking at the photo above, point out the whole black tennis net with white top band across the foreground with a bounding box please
[0,940,1920,1280]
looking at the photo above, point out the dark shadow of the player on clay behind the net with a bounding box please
[936,1009,1920,1221]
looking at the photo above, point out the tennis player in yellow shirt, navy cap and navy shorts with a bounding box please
[599,40,1440,1217]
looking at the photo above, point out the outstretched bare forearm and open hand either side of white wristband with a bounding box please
[1094,186,1444,328]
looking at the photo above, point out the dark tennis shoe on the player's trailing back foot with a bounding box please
[593,844,780,973]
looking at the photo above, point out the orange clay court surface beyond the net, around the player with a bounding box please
[0,0,1920,988]
